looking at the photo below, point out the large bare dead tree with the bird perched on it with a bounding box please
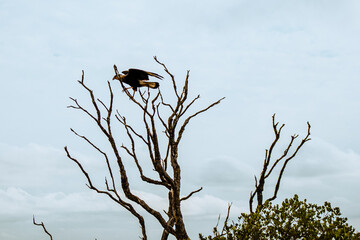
[65,57,223,240]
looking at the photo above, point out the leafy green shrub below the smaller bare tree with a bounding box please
[200,195,360,240]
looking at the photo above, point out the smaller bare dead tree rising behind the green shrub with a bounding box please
[249,114,311,213]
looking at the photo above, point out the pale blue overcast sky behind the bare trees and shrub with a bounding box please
[0,0,360,240]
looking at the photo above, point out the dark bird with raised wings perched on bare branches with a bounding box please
[113,68,164,94]
